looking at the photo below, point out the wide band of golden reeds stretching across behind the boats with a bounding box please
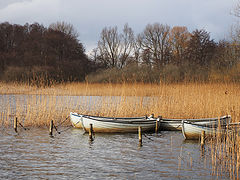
[0,83,240,126]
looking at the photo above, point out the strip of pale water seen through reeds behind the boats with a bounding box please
[0,94,154,120]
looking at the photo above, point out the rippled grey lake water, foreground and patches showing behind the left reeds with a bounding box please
[0,95,229,179]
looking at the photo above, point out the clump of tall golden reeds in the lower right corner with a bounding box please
[202,125,240,179]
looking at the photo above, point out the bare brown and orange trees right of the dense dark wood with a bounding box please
[88,23,240,82]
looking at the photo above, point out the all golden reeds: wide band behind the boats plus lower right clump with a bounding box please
[0,83,240,179]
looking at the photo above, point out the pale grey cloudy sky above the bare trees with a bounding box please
[0,0,237,51]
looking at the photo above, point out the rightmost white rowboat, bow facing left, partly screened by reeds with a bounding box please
[182,121,226,140]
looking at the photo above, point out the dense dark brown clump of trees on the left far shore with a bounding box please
[0,22,95,85]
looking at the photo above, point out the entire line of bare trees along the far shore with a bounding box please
[0,22,240,85]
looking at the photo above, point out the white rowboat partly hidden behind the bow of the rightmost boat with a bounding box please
[160,115,231,131]
